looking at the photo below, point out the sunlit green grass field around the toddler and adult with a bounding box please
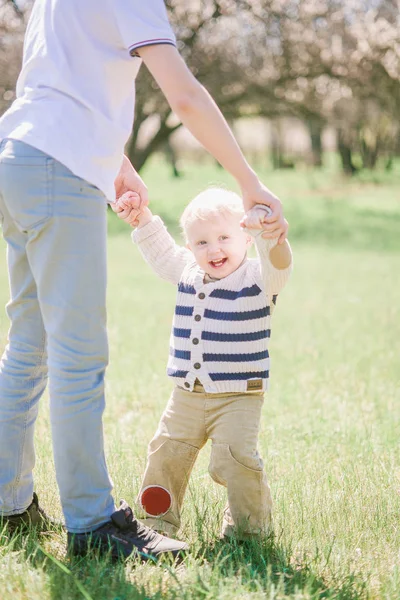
[0,161,400,600]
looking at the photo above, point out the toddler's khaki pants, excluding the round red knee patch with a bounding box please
[138,386,272,537]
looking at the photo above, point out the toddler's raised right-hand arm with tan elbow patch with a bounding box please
[242,205,293,310]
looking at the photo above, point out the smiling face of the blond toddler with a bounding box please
[186,213,252,279]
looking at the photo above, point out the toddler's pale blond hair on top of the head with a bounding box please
[179,187,244,238]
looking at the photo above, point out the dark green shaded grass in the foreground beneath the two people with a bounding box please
[0,532,367,600]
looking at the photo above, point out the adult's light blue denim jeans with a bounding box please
[0,140,115,533]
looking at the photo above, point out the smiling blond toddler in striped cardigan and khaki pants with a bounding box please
[119,189,292,538]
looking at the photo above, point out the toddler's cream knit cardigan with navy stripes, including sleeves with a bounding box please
[132,216,292,393]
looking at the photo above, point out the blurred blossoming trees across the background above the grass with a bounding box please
[0,0,400,175]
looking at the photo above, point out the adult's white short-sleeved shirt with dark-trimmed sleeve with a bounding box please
[0,0,175,201]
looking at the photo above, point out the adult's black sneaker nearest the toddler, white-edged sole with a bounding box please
[68,500,189,562]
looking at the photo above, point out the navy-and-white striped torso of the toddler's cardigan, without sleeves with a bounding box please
[168,274,270,391]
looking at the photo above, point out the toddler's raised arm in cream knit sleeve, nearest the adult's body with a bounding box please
[118,192,194,284]
